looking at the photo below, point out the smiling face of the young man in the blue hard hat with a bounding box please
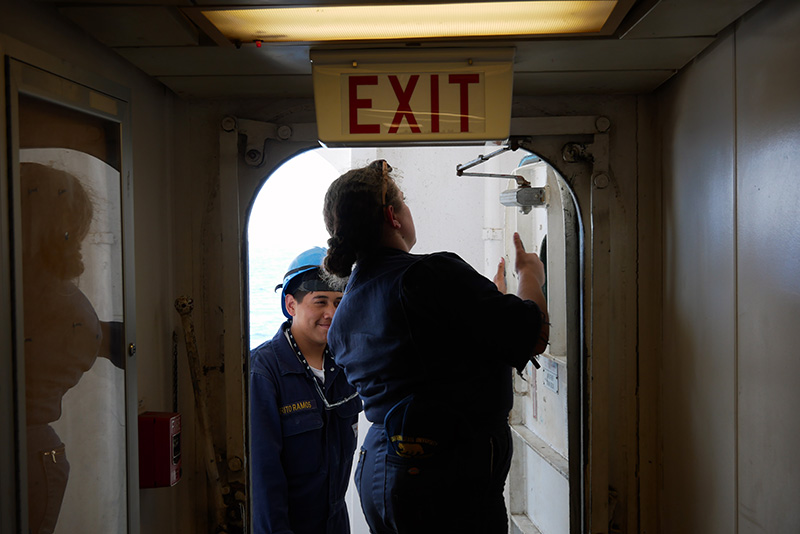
[286,291,342,351]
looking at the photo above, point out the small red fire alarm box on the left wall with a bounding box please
[139,412,181,488]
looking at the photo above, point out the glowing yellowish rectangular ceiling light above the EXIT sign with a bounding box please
[201,0,617,43]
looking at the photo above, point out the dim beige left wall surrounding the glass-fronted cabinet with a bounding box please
[0,0,191,534]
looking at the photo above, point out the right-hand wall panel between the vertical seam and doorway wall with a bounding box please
[661,29,736,533]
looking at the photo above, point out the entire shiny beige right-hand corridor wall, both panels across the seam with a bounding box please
[659,0,800,534]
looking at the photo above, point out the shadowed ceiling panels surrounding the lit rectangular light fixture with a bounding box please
[48,0,760,99]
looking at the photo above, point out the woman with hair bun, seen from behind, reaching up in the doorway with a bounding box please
[323,160,549,534]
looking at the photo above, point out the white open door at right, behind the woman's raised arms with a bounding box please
[505,158,581,534]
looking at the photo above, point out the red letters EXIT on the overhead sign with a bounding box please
[347,73,481,134]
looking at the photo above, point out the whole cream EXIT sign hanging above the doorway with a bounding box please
[311,49,514,144]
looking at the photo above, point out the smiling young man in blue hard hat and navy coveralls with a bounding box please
[250,247,361,534]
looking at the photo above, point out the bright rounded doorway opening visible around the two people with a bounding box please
[247,143,582,534]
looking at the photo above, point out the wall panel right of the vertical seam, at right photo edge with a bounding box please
[736,0,800,534]
